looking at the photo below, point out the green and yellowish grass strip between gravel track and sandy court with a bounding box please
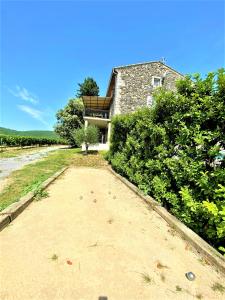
[0,149,106,211]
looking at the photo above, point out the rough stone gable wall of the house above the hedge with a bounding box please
[111,62,182,115]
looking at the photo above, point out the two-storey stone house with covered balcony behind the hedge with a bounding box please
[82,61,183,150]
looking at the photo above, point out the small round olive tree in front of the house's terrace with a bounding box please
[73,125,99,154]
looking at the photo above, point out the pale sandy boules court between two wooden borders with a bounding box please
[0,168,225,300]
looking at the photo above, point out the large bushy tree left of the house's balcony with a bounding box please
[55,99,84,146]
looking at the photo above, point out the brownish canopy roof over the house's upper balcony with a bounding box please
[82,96,112,110]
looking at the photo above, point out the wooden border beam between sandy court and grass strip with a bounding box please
[0,166,69,231]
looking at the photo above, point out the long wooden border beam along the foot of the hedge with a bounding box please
[107,165,225,274]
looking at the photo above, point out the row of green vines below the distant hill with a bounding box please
[0,134,65,147]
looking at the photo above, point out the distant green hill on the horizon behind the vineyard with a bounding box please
[0,127,59,138]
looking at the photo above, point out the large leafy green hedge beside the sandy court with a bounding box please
[108,69,225,251]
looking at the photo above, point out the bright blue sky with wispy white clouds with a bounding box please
[0,0,225,130]
